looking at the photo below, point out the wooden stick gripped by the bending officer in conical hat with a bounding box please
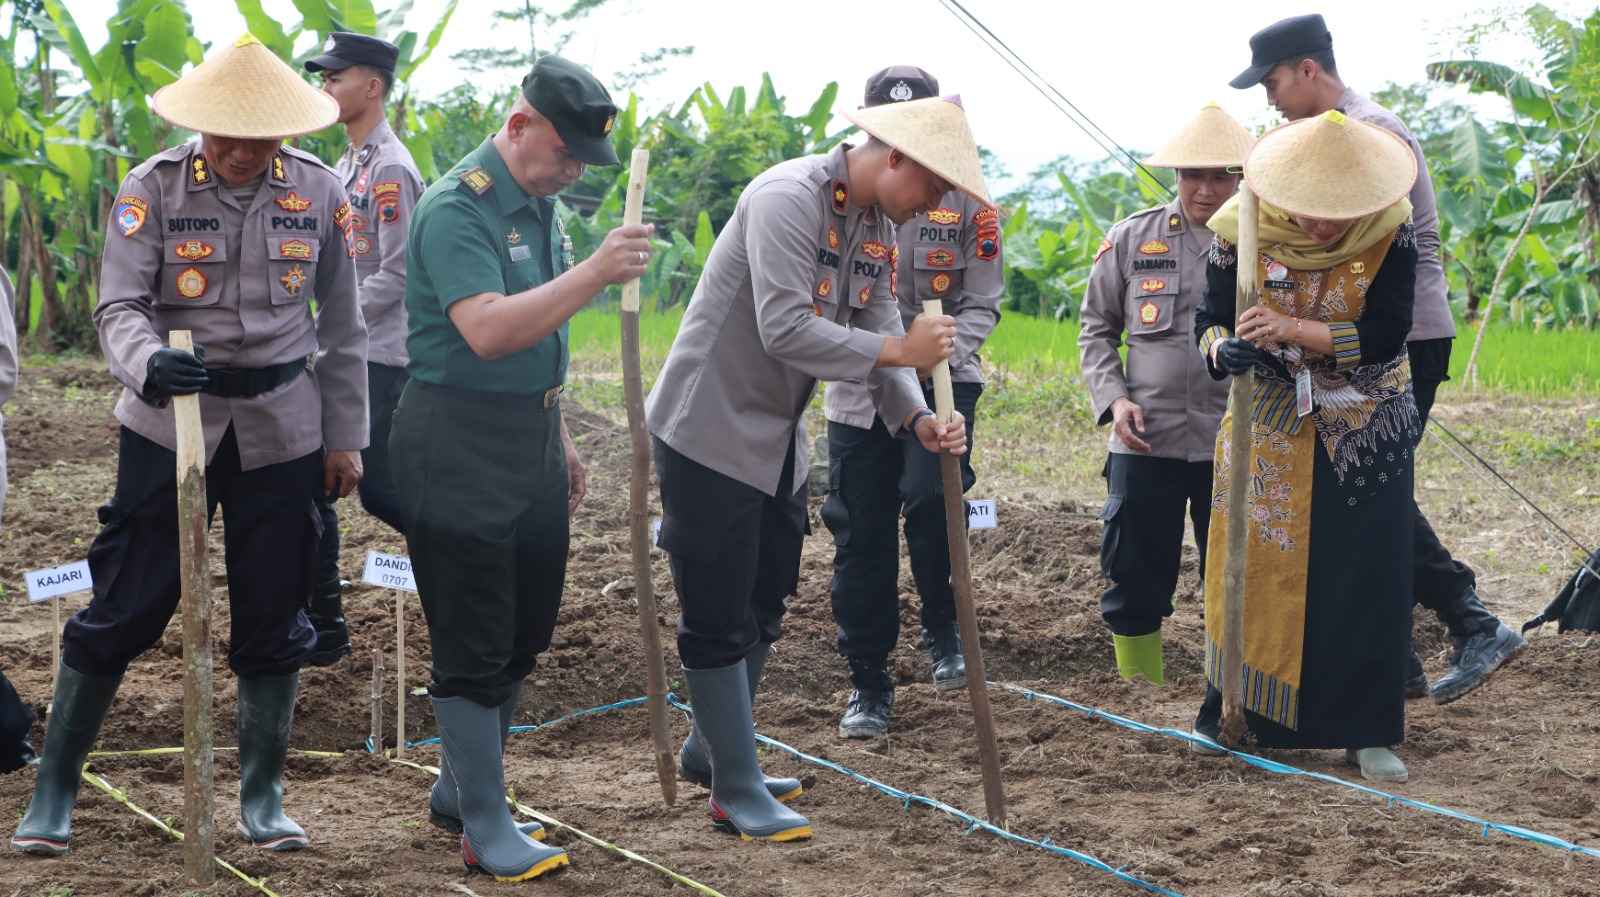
[922,299,1005,828]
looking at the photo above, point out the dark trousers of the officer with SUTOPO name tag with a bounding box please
[61,427,323,678]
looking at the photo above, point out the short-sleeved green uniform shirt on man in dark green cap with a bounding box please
[405,139,571,395]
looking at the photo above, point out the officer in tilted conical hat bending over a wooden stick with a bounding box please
[646,99,987,841]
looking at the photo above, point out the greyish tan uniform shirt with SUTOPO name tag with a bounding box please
[94,144,366,470]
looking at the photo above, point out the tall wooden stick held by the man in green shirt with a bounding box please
[622,149,678,806]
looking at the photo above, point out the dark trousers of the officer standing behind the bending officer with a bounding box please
[822,384,984,662]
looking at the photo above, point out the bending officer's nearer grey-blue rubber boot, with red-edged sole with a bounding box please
[683,660,811,841]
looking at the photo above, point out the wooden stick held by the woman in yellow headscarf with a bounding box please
[1221,182,1261,747]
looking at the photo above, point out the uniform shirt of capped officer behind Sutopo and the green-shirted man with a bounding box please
[334,122,422,368]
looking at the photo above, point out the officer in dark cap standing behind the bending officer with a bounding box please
[822,66,1005,739]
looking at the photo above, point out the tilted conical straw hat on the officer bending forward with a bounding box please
[845,96,994,206]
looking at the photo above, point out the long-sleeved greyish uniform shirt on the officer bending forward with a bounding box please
[646,146,925,496]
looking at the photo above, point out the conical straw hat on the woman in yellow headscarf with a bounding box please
[1245,110,1416,221]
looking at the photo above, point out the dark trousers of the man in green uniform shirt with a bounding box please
[389,381,568,707]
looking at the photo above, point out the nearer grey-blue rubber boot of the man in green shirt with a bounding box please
[434,697,568,881]
